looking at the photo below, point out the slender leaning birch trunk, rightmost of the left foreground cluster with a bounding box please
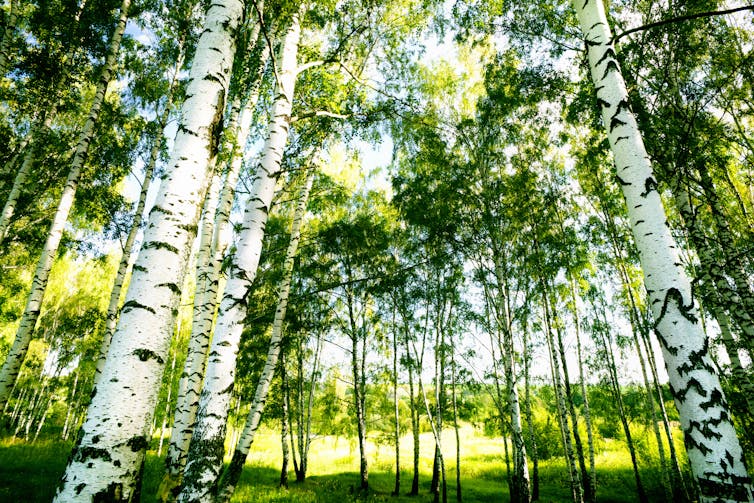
[217,168,314,501]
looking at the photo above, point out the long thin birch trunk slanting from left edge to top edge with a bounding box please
[0,0,131,410]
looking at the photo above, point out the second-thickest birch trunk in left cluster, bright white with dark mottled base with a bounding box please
[179,9,301,503]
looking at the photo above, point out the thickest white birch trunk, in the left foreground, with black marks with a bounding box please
[55,0,243,503]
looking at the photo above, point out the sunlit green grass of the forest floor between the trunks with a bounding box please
[0,428,662,503]
